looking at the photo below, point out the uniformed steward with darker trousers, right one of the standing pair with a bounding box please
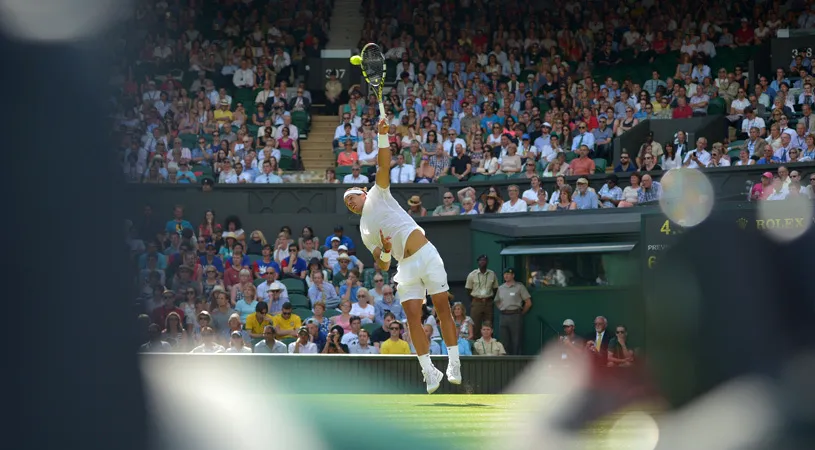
[495,267,532,355]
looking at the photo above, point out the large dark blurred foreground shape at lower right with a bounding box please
[518,213,815,450]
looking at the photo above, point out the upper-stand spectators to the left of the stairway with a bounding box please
[110,0,332,184]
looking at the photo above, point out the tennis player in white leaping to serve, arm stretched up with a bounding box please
[344,120,461,394]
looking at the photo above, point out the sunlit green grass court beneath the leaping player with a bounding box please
[331,394,652,450]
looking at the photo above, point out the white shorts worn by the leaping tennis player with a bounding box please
[393,242,450,302]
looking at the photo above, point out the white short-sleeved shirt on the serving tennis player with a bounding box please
[359,184,424,261]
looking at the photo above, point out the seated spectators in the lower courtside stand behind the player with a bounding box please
[134,205,531,355]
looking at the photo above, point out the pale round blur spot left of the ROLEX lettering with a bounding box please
[659,169,714,227]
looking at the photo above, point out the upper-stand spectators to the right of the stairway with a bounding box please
[318,0,815,192]
